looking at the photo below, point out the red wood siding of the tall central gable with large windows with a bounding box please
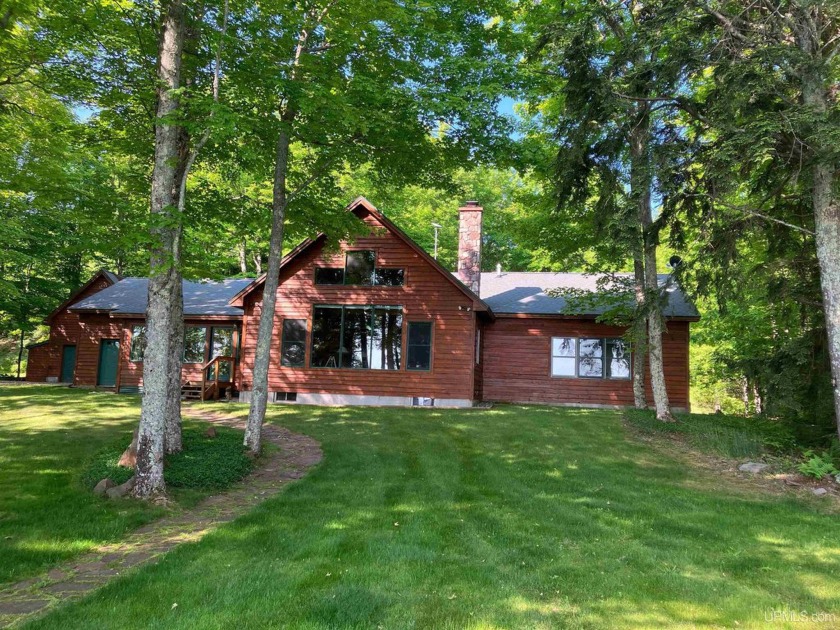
[241,215,475,400]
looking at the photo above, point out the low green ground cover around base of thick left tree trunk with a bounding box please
[82,425,253,490]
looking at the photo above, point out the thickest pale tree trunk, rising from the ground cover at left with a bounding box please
[134,0,185,499]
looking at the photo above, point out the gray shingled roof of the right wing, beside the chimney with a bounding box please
[481,271,700,317]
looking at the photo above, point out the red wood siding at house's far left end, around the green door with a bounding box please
[26,277,111,385]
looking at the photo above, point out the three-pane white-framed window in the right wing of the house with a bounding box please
[551,337,630,379]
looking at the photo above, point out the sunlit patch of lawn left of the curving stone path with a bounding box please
[0,385,248,584]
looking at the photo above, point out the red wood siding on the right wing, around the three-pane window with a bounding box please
[482,317,689,409]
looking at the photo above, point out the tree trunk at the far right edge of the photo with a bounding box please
[796,13,840,437]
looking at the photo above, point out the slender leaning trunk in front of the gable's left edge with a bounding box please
[245,129,289,455]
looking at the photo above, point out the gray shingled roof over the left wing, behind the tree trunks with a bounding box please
[70,278,253,316]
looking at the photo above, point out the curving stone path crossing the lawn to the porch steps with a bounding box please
[0,405,322,628]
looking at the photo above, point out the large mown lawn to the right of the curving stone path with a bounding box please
[11,398,840,629]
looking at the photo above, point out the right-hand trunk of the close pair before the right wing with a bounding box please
[630,103,674,422]
